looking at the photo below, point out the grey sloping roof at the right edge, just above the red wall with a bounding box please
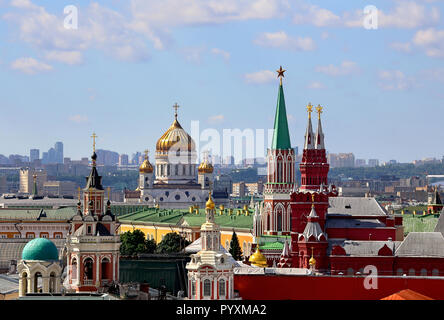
[395,232,444,257]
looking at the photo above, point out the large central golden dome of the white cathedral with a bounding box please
[156,118,196,152]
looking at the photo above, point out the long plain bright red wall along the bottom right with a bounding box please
[234,275,444,300]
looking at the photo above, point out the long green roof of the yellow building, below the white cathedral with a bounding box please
[118,208,253,229]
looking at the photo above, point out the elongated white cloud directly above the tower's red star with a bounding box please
[254,31,316,51]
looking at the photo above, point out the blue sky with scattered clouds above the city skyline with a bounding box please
[0,0,444,162]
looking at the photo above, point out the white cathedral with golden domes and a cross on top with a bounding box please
[125,104,228,209]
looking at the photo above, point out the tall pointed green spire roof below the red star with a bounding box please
[271,84,291,149]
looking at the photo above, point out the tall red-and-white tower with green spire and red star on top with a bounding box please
[262,66,295,235]
